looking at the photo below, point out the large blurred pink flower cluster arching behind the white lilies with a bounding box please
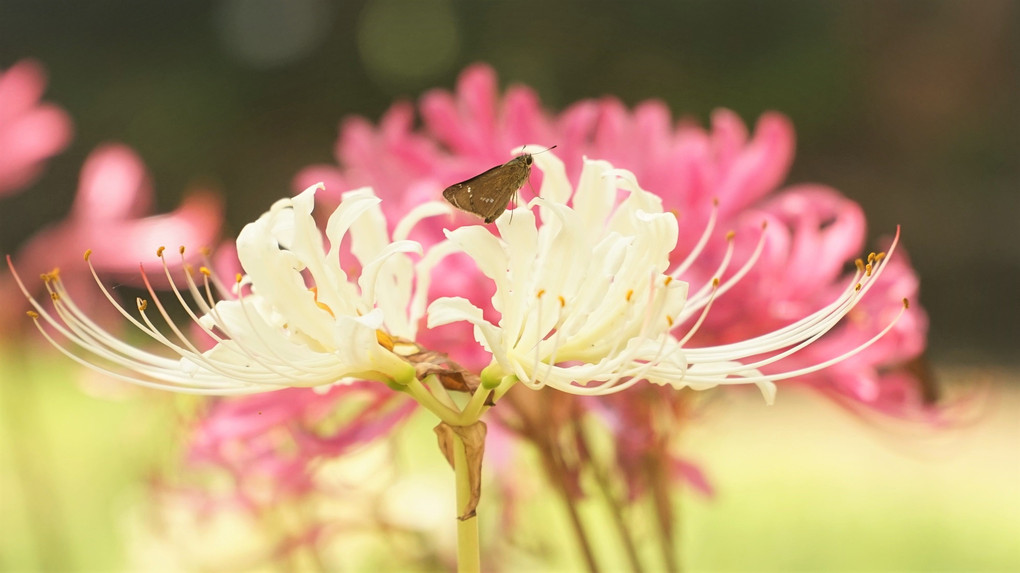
[295,65,927,417]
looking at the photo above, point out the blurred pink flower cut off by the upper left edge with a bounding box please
[0,60,71,197]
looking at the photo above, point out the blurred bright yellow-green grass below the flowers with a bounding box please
[0,348,1020,571]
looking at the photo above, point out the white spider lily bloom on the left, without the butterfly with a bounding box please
[8,185,449,395]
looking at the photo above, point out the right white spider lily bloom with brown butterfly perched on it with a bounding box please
[428,153,906,403]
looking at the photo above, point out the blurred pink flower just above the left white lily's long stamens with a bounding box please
[0,144,222,336]
